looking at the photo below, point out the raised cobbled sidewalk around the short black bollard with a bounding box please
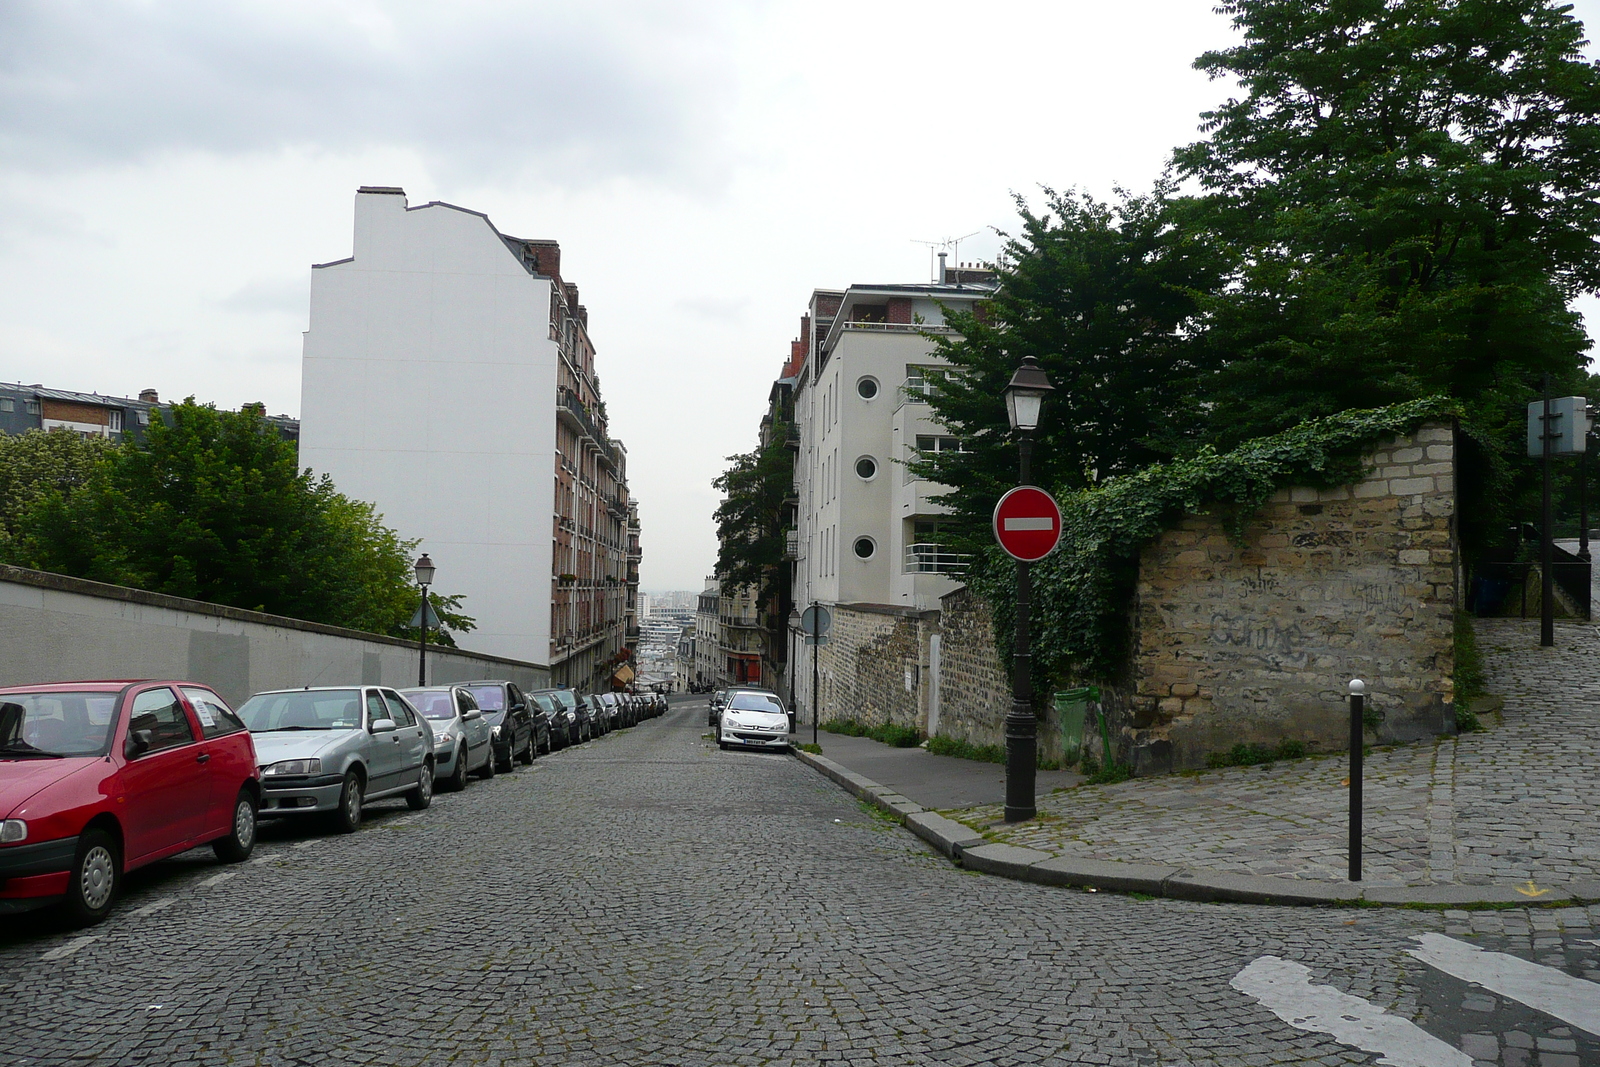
[946,619,1600,885]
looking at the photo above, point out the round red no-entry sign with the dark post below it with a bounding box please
[994,485,1061,822]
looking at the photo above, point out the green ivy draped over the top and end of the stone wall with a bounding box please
[966,397,1459,693]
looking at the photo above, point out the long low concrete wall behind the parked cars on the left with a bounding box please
[0,566,550,704]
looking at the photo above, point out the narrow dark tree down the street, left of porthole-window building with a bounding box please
[712,422,795,603]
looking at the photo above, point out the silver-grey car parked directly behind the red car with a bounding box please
[238,686,434,833]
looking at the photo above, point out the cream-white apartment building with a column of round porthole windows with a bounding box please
[794,283,992,611]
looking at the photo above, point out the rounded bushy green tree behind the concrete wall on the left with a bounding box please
[11,398,472,633]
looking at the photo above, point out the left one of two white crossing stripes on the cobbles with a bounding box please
[1229,957,1472,1067]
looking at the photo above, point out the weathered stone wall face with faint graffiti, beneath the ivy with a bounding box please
[1123,426,1456,773]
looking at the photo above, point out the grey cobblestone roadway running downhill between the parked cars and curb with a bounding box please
[0,702,1600,1067]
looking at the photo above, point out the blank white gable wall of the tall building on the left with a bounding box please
[299,194,558,662]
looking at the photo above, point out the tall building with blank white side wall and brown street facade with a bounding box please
[299,187,637,688]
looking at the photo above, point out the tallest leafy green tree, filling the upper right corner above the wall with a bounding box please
[1174,0,1600,446]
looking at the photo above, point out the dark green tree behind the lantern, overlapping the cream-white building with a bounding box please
[912,186,1227,541]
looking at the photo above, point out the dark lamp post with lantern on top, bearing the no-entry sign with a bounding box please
[1005,355,1054,822]
